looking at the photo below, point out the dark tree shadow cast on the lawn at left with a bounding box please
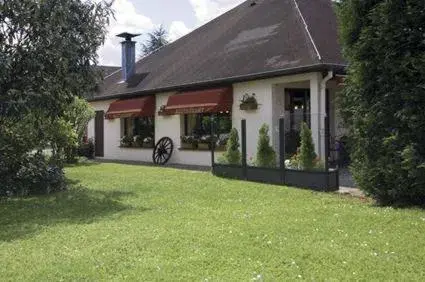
[0,185,147,242]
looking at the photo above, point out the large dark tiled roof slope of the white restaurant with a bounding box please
[95,0,345,99]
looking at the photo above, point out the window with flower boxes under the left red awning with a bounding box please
[121,117,155,148]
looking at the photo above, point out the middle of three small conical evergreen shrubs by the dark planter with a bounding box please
[255,124,276,167]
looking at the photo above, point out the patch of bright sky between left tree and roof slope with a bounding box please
[99,0,244,66]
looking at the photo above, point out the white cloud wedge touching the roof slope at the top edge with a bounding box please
[189,0,244,24]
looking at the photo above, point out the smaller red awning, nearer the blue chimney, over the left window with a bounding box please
[106,96,155,119]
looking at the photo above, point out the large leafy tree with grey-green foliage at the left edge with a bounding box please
[0,0,111,195]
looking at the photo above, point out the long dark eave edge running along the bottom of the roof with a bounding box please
[87,64,347,102]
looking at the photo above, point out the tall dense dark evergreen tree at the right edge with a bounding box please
[338,0,425,204]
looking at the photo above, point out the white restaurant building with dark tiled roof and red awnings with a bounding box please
[88,0,346,165]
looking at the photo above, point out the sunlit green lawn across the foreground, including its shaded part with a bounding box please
[0,164,425,281]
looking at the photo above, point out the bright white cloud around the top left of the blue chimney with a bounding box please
[98,0,154,66]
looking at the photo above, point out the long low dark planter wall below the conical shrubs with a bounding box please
[213,164,339,192]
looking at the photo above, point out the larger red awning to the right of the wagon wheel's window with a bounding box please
[160,87,233,115]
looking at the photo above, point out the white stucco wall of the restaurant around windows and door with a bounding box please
[88,73,346,166]
